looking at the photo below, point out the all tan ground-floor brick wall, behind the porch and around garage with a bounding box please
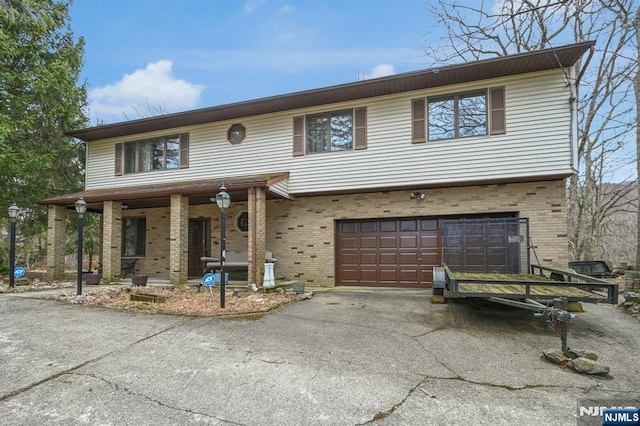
[125,180,568,286]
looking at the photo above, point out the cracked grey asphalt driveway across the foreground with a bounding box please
[0,290,640,425]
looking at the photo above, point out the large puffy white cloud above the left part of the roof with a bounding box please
[89,59,204,122]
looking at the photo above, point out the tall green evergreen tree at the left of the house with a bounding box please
[0,0,88,270]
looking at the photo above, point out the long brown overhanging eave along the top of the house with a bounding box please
[65,41,595,142]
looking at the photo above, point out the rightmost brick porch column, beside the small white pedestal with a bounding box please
[248,187,267,286]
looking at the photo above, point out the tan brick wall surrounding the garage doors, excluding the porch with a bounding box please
[267,181,568,286]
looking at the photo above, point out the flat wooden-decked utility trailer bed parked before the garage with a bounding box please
[433,264,618,313]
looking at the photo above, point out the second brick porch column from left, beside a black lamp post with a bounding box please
[102,201,122,282]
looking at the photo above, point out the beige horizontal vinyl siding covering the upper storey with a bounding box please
[87,70,572,194]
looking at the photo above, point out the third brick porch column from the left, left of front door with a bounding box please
[169,194,189,285]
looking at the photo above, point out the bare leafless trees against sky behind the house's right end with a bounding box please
[427,0,638,266]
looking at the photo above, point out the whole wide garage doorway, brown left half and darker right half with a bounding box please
[336,217,529,288]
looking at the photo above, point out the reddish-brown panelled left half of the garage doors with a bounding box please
[336,218,442,287]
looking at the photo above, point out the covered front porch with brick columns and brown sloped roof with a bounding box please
[41,173,288,287]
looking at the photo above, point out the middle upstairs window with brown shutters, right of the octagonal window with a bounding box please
[293,107,367,156]
